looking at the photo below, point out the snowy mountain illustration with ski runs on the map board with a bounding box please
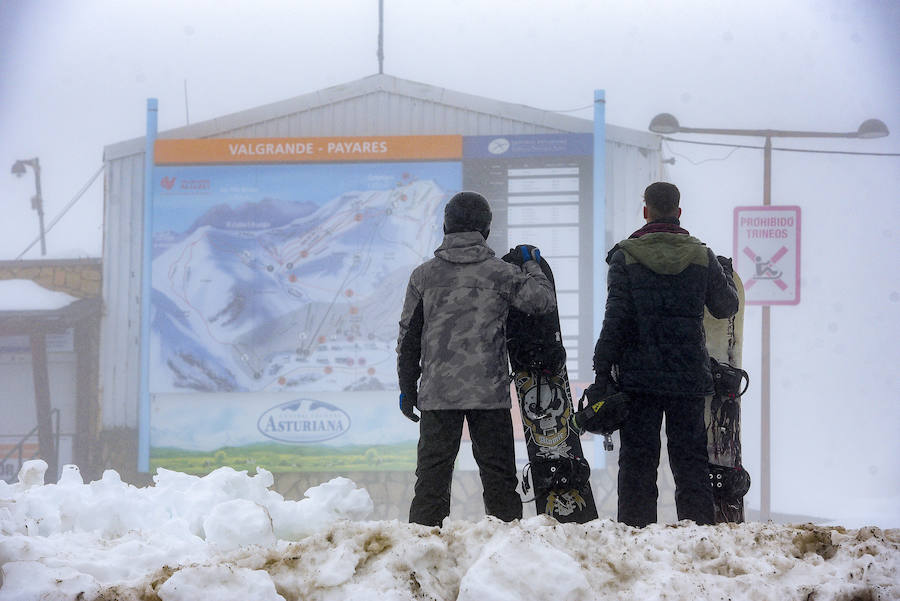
[150,174,458,392]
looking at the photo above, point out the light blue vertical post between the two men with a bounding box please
[591,90,606,470]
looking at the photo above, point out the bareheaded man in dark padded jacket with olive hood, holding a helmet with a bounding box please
[590,182,738,527]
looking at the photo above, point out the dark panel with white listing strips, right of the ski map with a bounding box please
[463,134,593,380]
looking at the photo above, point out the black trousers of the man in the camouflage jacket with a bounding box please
[409,409,522,526]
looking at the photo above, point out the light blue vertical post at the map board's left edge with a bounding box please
[138,98,159,472]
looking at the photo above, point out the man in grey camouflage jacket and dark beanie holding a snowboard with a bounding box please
[397,192,556,526]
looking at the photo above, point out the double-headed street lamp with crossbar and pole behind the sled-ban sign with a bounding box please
[648,113,890,521]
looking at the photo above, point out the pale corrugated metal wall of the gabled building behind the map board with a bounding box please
[100,76,659,429]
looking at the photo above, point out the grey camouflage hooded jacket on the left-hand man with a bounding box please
[397,232,556,411]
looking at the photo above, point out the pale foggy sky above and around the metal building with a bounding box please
[0,0,900,525]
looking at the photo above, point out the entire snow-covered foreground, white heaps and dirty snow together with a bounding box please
[0,460,900,601]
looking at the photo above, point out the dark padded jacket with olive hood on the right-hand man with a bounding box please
[594,220,738,396]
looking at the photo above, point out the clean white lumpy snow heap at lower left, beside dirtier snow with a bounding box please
[0,460,373,600]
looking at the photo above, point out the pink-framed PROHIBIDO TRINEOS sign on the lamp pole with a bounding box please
[733,206,800,305]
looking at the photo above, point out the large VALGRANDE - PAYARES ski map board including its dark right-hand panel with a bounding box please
[142,134,592,473]
